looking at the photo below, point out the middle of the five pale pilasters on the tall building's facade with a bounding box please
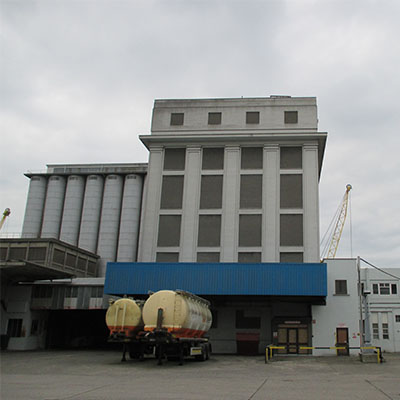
[221,146,240,262]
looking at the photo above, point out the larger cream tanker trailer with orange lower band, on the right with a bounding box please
[142,290,212,364]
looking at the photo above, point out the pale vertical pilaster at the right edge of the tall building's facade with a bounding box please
[303,144,320,262]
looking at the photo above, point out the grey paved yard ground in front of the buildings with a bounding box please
[0,350,400,400]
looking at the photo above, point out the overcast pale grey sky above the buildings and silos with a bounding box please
[0,0,400,267]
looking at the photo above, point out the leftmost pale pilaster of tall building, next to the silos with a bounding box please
[138,147,163,262]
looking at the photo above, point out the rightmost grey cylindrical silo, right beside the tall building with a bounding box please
[117,174,142,262]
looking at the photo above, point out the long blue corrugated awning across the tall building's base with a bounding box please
[104,263,327,296]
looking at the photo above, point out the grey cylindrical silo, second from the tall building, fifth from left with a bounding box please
[97,175,124,276]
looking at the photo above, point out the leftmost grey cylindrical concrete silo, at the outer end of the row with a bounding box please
[22,176,47,238]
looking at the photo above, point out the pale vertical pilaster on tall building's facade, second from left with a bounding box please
[179,147,201,262]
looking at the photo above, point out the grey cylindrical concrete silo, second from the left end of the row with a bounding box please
[41,175,65,239]
